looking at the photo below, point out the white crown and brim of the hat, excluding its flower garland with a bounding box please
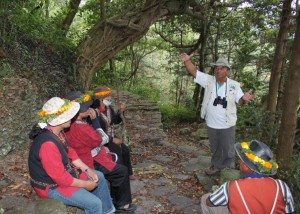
[43,97,80,126]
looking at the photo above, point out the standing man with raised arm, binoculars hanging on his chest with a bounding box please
[179,53,255,175]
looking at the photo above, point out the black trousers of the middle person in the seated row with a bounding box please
[94,162,132,207]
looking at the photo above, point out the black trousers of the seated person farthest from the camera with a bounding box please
[105,142,133,175]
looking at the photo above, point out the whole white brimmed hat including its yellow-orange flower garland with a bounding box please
[38,97,80,126]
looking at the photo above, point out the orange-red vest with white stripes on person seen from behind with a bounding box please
[228,178,285,214]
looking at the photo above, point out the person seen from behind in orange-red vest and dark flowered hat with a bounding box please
[201,140,295,214]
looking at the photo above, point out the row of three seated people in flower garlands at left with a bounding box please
[28,86,137,214]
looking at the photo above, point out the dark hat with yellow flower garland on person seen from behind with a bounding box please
[234,140,278,175]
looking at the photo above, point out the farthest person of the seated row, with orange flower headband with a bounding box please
[91,86,135,180]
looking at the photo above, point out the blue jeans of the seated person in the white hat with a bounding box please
[48,170,115,214]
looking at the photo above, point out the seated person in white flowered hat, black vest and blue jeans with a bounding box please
[28,97,115,214]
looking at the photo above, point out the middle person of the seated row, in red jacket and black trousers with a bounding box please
[66,91,137,212]
